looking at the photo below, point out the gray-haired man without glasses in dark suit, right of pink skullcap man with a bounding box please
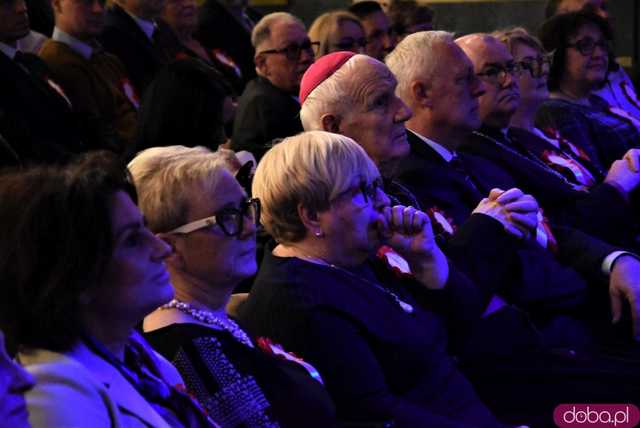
[387,32,640,342]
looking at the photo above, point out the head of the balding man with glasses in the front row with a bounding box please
[456,34,520,128]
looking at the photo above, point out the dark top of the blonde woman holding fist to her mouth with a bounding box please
[240,252,499,428]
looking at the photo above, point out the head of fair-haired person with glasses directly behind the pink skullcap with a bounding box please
[308,10,367,59]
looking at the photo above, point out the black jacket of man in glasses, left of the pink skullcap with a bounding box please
[231,77,302,160]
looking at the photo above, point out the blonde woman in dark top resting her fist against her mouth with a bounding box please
[240,131,500,427]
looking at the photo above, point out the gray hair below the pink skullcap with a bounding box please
[300,54,377,131]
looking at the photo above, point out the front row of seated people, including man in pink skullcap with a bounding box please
[0,0,640,427]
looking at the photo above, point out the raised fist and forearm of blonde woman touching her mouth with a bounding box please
[379,205,449,289]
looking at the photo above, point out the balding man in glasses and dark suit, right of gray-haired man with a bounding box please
[458,34,640,248]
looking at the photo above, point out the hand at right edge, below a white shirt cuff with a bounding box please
[609,256,640,340]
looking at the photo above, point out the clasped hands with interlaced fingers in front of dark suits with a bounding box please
[473,188,540,239]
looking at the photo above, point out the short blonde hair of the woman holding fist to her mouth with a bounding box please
[252,131,380,244]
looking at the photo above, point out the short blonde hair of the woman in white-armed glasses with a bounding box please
[129,146,237,233]
